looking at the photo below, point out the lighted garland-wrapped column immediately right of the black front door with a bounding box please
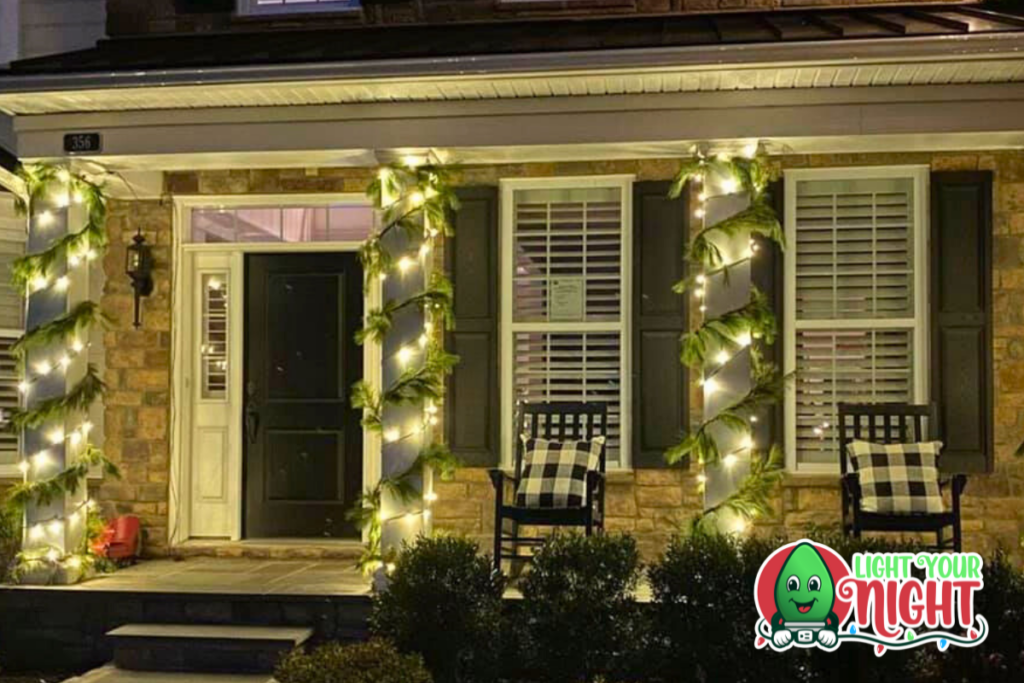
[350,159,458,571]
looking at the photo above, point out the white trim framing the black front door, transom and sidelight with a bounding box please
[168,193,383,546]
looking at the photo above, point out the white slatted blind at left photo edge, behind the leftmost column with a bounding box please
[0,196,26,466]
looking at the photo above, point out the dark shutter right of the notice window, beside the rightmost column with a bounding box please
[633,181,689,468]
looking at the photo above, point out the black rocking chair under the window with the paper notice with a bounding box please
[490,402,608,571]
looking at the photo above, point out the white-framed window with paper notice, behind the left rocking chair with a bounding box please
[502,177,632,467]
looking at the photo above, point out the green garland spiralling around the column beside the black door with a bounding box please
[348,165,459,571]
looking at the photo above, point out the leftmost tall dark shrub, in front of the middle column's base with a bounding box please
[371,536,505,682]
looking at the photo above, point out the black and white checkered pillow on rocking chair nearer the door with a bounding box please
[516,436,604,508]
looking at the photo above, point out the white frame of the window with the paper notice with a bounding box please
[500,175,636,471]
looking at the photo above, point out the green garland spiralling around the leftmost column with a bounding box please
[5,164,120,578]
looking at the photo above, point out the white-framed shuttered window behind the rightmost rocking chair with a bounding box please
[785,168,928,472]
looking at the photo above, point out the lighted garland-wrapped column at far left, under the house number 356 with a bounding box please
[4,165,117,583]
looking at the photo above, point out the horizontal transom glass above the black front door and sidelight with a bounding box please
[189,204,374,244]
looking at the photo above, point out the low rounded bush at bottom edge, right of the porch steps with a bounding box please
[274,640,431,683]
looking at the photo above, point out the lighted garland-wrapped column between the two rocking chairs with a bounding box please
[666,145,783,532]
